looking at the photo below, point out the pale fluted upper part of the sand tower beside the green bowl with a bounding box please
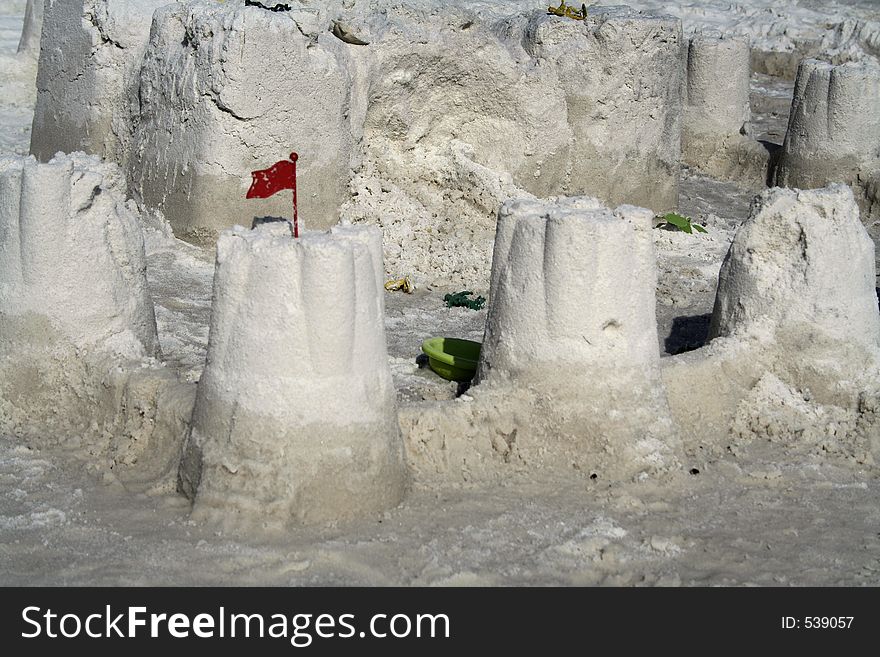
[480,197,660,380]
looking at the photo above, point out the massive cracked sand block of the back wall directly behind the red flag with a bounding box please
[128,2,355,244]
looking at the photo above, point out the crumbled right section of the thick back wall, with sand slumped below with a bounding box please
[342,3,682,285]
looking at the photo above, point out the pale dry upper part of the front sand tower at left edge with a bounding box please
[0,153,158,357]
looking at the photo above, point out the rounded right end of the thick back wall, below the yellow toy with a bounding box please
[524,7,684,211]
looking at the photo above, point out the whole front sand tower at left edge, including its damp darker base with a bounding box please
[0,153,192,488]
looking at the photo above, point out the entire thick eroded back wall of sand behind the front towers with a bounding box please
[31,0,683,288]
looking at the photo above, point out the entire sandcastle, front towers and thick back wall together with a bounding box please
[6,0,880,530]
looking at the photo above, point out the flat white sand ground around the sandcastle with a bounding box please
[0,0,880,586]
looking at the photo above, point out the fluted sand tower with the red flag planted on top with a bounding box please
[179,224,407,528]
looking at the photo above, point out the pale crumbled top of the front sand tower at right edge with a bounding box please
[709,184,880,348]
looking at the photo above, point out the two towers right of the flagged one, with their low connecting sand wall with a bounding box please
[401,185,880,482]
